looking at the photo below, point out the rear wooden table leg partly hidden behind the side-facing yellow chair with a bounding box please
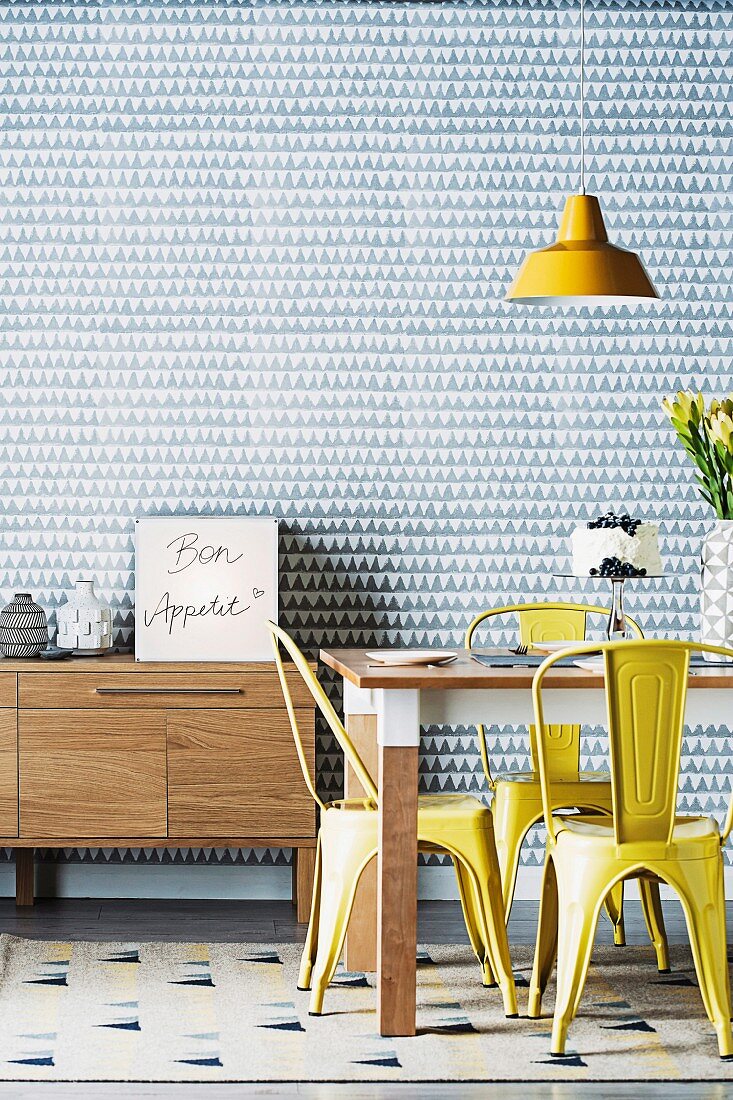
[343,714,379,972]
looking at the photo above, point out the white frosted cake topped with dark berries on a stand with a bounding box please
[571,513,661,576]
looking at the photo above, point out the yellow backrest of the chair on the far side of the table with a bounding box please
[466,602,644,784]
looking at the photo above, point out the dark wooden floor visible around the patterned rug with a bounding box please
[0,895,733,1100]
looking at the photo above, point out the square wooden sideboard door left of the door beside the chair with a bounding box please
[18,708,166,839]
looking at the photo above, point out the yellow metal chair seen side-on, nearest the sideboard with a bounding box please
[267,623,517,1016]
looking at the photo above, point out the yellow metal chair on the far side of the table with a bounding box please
[464,603,669,972]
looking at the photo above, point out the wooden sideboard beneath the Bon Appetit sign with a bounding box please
[0,655,316,920]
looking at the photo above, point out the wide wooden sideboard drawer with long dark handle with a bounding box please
[19,668,314,711]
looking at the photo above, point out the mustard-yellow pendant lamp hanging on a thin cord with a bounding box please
[506,0,659,306]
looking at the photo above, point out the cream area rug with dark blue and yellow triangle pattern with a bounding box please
[0,936,733,1081]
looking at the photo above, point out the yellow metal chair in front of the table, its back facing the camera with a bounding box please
[528,640,733,1058]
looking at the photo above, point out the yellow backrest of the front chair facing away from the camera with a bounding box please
[533,639,733,846]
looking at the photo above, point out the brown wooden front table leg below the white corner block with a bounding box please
[376,739,418,1035]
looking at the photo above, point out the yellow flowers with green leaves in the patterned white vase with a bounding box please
[661,389,733,519]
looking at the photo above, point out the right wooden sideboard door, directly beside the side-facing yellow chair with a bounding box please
[167,706,316,839]
